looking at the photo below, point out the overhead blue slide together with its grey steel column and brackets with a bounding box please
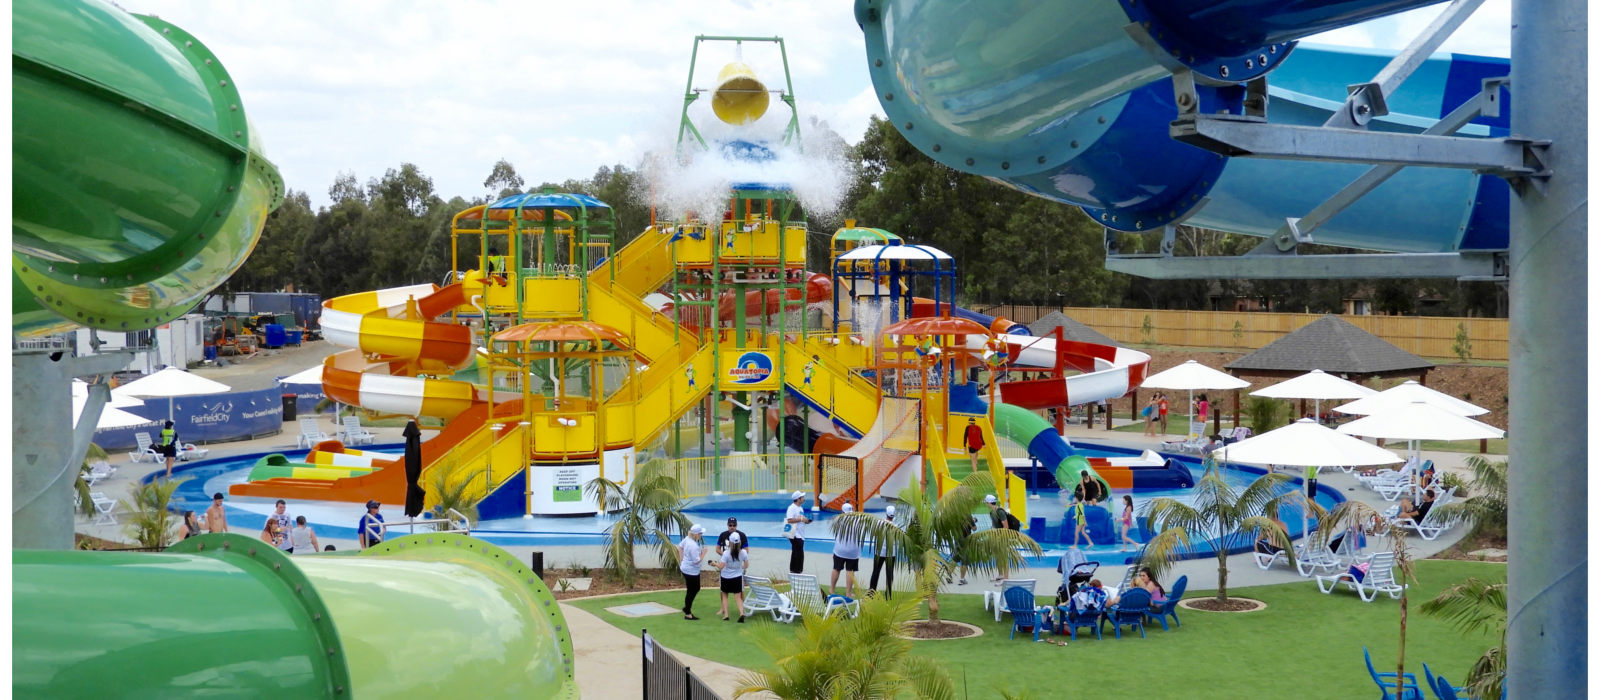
[854,0,1589,697]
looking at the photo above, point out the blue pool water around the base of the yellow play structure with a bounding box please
[173,443,1342,566]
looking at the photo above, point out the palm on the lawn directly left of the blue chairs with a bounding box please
[832,471,1042,623]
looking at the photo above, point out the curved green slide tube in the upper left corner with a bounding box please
[11,0,283,334]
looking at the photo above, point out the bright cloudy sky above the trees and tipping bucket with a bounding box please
[131,0,1510,205]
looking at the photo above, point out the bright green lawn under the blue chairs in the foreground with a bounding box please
[573,561,1506,700]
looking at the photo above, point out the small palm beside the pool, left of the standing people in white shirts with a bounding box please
[584,460,690,588]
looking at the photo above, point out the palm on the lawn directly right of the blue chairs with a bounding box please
[1139,460,1323,603]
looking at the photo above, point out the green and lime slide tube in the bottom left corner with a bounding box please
[11,532,578,700]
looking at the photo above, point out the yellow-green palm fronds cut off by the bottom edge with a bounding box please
[733,595,955,700]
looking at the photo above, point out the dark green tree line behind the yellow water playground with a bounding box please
[218,118,1506,316]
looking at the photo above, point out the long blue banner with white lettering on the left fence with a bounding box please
[94,387,283,451]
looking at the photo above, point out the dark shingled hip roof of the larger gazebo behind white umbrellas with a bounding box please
[1224,313,1434,374]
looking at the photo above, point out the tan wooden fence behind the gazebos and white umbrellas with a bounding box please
[979,304,1510,361]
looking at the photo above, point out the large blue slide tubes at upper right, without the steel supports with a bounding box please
[856,0,1509,253]
